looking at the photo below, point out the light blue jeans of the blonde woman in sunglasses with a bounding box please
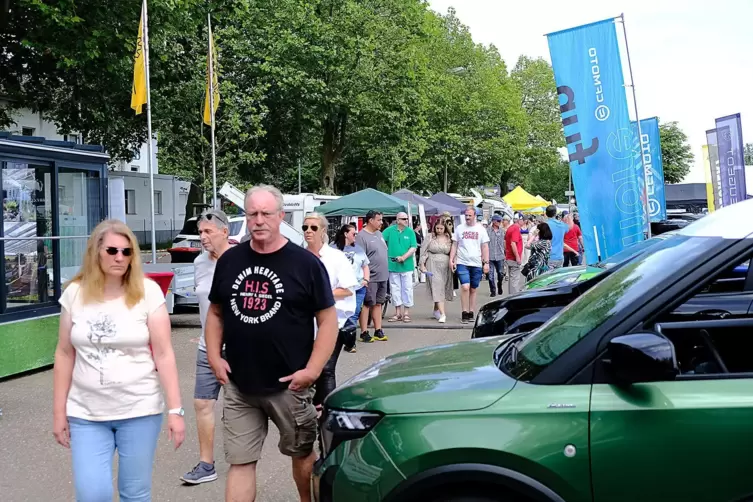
[68,415,162,502]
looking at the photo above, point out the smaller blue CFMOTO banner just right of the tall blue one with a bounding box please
[631,117,667,221]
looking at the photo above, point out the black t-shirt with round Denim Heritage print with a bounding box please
[209,242,335,394]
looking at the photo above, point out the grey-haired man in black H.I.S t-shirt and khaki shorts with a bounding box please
[205,185,337,502]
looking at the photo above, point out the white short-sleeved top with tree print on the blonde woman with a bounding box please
[60,279,165,421]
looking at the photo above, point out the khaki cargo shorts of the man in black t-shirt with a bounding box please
[222,382,317,465]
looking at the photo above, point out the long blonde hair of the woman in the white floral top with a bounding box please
[65,220,144,308]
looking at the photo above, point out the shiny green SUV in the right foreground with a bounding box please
[314,200,753,502]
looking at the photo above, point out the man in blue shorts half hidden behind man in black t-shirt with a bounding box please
[180,209,230,485]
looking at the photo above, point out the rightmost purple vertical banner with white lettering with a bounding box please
[716,113,747,206]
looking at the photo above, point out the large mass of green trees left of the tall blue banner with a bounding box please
[0,0,567,202]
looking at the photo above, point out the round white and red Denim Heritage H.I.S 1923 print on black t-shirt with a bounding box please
[230,267,285,324]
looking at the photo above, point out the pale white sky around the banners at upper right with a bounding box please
[429,0,753,182]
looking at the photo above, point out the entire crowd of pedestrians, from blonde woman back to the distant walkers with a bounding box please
[53,185,583,502]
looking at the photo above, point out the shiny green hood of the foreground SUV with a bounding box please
[326,336,516,414]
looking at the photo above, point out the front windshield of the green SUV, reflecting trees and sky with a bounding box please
[502,235,723,381]
